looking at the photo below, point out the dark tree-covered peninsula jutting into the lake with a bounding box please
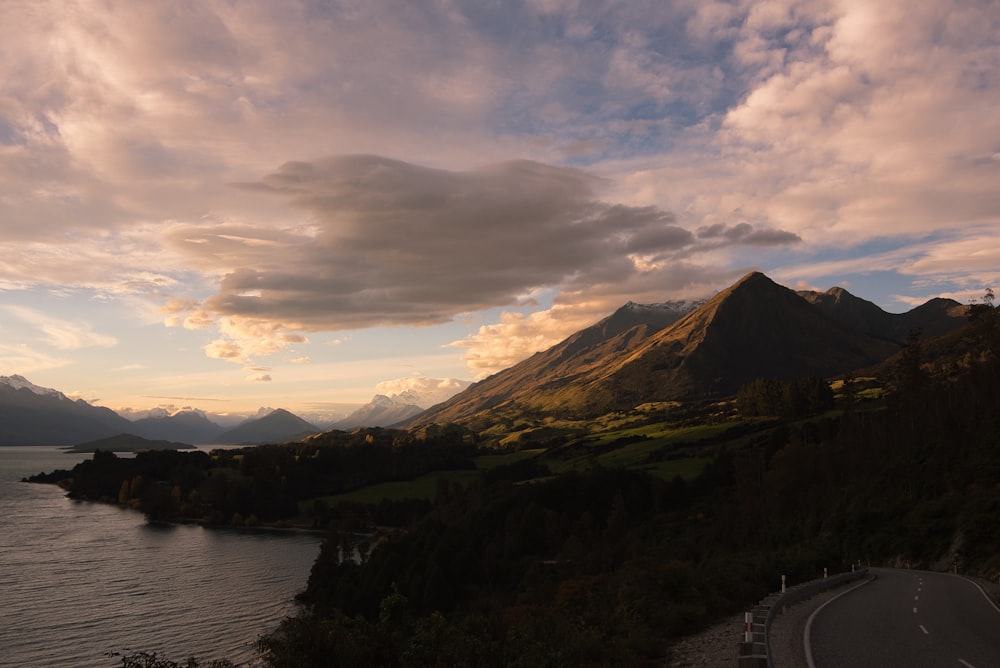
[29,428,475,525]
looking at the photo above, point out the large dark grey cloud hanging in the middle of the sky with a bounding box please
[166,156,796,342]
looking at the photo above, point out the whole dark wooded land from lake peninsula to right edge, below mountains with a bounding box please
[39,299,1000,668]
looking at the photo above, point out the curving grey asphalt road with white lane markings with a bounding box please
[805,568,1000,668]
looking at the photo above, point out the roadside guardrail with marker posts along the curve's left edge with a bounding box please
[736,568,868,668]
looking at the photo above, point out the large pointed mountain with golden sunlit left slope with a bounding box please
[409,272,965,424]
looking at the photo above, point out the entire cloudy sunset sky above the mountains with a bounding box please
[0,0,1000,420]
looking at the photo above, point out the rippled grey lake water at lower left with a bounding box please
[0,447,320,668]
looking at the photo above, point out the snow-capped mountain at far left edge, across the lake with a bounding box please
[0,375,131,445]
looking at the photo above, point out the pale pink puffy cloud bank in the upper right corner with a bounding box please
[717,2,1000,243]
